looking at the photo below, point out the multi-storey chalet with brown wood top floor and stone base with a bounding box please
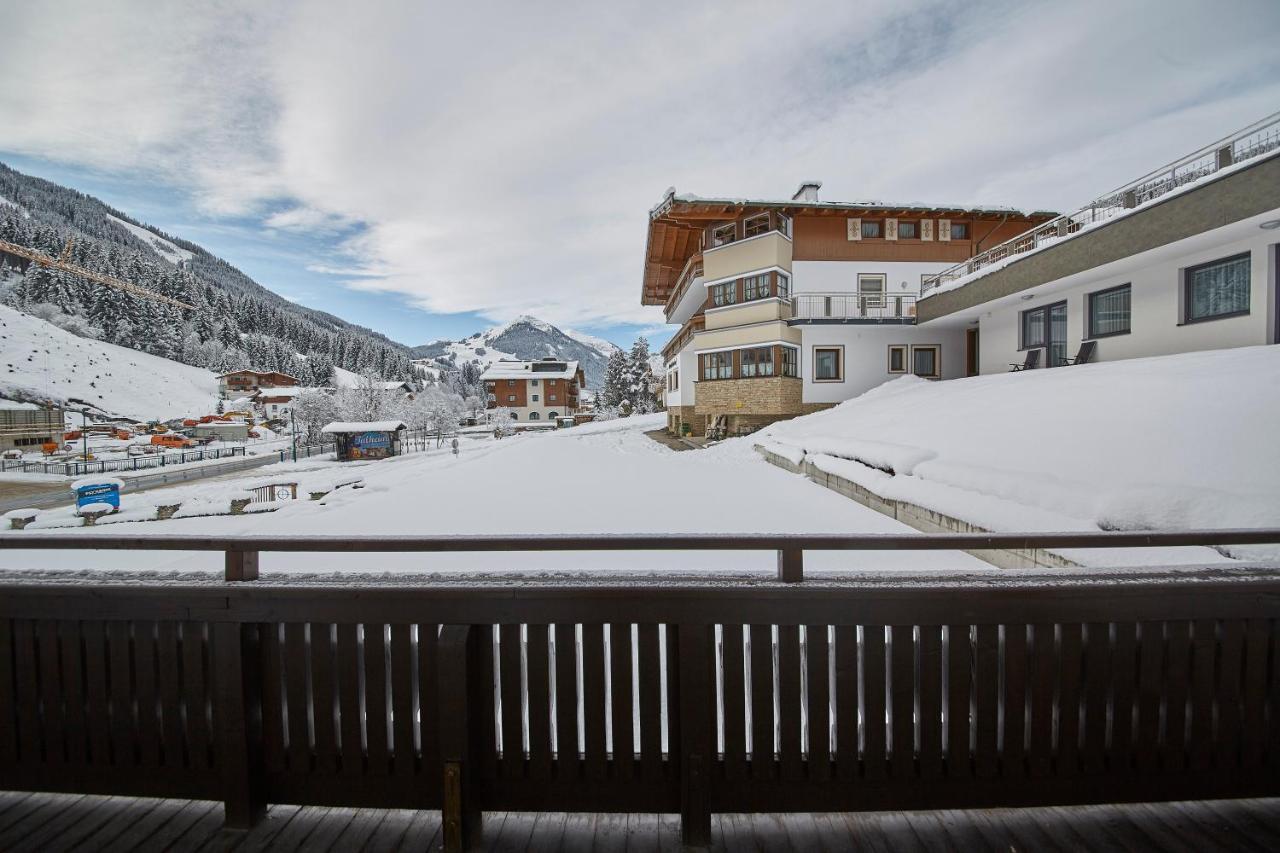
[641,182,1053,435]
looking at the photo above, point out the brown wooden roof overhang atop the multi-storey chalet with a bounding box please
[640,196,1057,306]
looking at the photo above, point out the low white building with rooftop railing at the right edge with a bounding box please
[916,113,1280,374]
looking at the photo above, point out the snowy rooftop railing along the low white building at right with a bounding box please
[920,113,1280,296]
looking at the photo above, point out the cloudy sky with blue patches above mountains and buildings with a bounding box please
[0,0,1280,343]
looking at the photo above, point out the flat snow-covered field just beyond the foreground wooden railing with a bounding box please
[5,415,984,573]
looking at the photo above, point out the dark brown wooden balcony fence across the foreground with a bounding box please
[0,530,1280,849]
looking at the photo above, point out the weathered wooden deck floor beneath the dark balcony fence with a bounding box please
[0,793,1280,853]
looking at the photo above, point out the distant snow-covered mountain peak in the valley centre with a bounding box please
[411,316,618,391]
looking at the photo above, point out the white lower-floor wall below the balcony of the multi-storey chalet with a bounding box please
[797,323,964,403]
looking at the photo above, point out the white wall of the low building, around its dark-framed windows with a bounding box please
[977,231,1277,374]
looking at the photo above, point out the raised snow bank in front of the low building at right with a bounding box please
[756,346,1280,564]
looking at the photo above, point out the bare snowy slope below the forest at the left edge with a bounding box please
[0,305,218,420]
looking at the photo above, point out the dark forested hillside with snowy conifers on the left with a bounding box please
[0,158,415,384]
